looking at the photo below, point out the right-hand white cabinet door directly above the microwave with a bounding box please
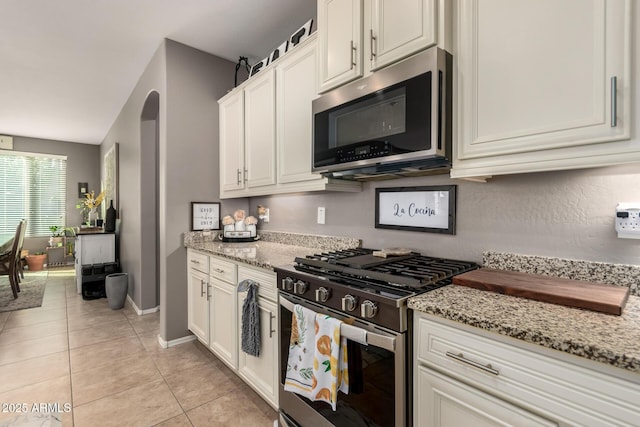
[368,0,437,70]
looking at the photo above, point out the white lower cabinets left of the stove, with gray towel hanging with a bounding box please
[187,249,278,408]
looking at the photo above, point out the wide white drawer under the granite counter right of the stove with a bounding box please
[414,313,640,426]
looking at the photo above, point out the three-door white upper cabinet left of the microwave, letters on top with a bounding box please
[218,33,362,199]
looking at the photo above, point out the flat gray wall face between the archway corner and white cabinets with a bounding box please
[160,40,247,340]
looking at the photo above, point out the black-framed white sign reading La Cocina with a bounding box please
[376,185,456,234]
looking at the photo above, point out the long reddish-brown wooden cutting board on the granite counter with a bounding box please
[453,268,629,316]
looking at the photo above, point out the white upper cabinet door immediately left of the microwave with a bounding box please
[276,37,322,183]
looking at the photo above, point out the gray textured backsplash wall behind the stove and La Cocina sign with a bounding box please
[249,165,640,264]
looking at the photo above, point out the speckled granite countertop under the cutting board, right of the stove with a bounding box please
[409,253,640,373]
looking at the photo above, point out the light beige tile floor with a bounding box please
[0,268,276,427]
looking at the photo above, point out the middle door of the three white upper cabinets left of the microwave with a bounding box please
[244,68,276,188]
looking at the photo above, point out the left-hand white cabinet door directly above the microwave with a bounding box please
[318,0,363,92]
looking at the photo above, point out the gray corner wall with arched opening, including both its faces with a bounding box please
[101,40,248,341]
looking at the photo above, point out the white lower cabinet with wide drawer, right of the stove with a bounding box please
[413,312,640,427]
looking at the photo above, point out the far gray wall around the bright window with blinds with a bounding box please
[8,136,101,252]
